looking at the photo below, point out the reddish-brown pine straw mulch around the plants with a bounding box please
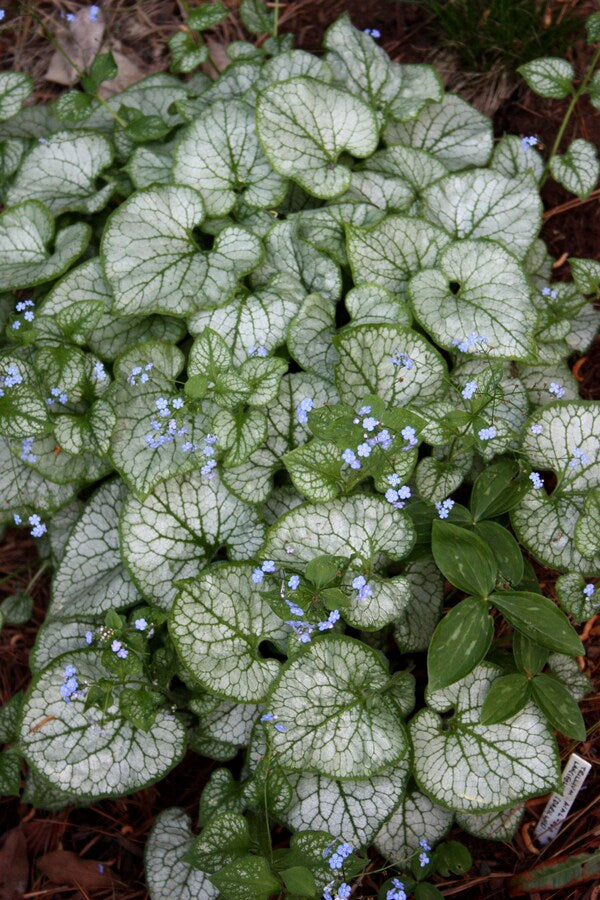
[0,0,600,900]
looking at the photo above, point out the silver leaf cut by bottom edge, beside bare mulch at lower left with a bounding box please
[144,807,219,900]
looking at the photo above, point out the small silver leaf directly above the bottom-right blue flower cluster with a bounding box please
[373,789,454,867]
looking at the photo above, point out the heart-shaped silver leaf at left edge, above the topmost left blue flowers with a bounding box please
[0,200,92,290]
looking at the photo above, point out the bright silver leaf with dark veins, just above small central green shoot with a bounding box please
[188,276,304,365]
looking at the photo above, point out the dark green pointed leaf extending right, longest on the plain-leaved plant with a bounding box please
[490,591,585,656]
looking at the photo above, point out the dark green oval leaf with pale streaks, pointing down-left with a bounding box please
[427,597,494,691]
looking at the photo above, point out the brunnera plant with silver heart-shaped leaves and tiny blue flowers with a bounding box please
[0,0,600,900]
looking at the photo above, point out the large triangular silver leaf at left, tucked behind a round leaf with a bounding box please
[48,481,139,618]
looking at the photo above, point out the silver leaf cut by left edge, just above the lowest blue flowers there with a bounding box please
[0,439,78,525]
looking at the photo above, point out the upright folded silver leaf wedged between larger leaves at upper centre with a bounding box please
[251,219,342,302]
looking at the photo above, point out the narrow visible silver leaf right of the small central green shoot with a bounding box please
[222,372,339,503]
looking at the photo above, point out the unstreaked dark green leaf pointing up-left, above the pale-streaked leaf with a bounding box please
[431,519,498,597]
